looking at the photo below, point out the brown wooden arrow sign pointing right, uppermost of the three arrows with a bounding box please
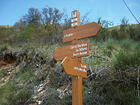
[63,22,101,43]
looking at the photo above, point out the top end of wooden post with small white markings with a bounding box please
[71,10,80,27]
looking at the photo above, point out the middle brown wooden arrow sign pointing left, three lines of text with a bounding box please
[53,41,89,60]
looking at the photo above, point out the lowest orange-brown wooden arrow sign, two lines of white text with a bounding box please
[61,57,87,78]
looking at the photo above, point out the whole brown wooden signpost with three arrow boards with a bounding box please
[52,10,101,105]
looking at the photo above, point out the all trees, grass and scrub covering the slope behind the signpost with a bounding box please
[0,7,140,105]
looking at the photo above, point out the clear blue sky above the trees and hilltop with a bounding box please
[0,0,140,25]
